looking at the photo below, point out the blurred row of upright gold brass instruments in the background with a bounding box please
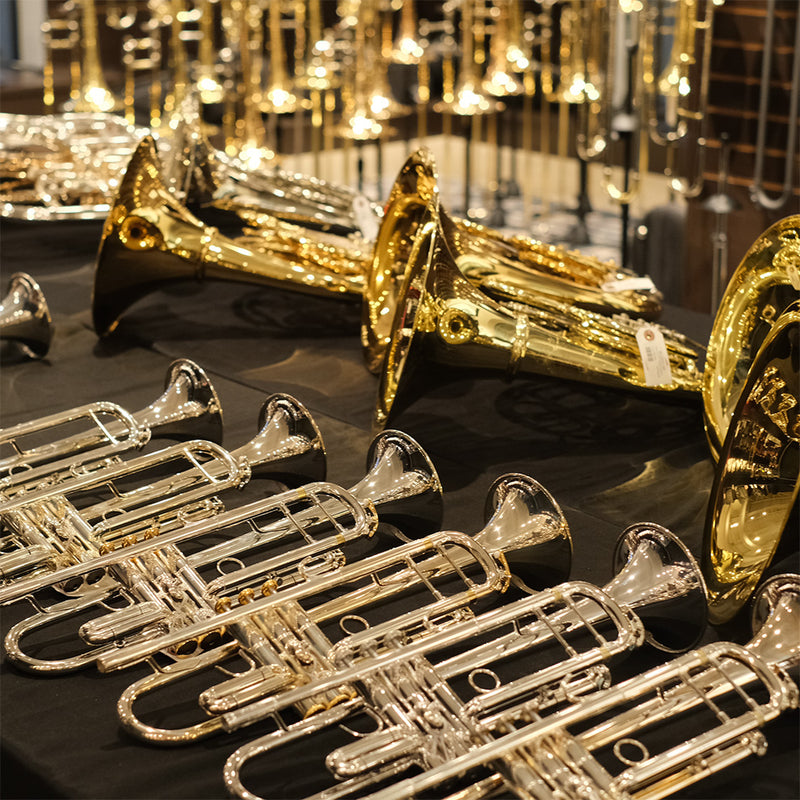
[6,0,764,216]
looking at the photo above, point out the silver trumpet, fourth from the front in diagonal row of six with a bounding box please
[0,431,441,672]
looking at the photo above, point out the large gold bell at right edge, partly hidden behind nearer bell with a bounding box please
[701,214,800,460]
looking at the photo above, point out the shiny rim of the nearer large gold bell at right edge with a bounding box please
[701,300,800,624]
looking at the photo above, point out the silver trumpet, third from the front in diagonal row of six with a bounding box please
[98,475,571,744]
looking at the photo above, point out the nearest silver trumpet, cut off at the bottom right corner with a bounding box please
[350,575,800,800]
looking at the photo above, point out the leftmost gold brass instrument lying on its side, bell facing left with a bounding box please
[92,136,366,335]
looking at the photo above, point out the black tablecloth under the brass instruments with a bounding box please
[0,222,800,800]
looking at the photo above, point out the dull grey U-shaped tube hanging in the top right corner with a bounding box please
[750,0,800,211]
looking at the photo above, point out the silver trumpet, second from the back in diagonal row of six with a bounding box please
[0,394,325,592]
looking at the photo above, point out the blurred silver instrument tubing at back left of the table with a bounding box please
[0,113,145,221]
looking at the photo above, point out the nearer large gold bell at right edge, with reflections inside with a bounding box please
[702,298,800,624]
